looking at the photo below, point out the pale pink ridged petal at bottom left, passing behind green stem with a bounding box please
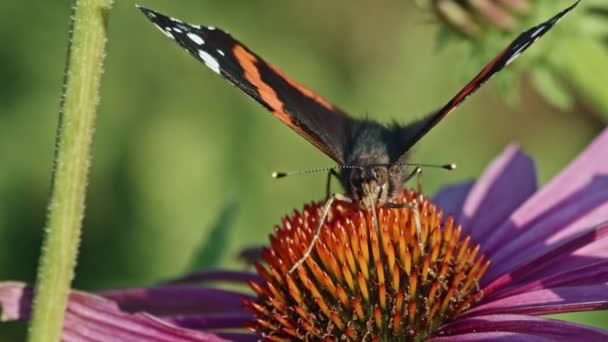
[0,283,234,342]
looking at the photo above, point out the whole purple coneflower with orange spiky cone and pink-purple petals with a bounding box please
[0,130,608,341]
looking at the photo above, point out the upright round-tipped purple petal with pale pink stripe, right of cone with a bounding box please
[458,145,536,240]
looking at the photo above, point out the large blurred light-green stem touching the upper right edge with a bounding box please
[549,36,608,121]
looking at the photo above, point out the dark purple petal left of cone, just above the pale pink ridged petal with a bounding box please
[98,285,255,316]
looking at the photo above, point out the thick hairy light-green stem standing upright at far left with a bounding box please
[28,0,112,342]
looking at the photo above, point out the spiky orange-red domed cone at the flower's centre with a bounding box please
[245,191,490,341]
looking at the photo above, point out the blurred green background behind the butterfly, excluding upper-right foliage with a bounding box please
[0,0,608,339]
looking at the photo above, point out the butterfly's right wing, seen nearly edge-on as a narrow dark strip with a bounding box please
[395,0,580,164]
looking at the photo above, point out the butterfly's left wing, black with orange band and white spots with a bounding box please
[138,6,355,164]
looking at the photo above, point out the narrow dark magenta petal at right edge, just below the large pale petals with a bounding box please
[483,223,608,293]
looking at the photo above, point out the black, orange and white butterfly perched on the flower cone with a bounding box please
[138,0,580,271]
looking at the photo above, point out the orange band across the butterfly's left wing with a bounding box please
[232,45,291,117]
